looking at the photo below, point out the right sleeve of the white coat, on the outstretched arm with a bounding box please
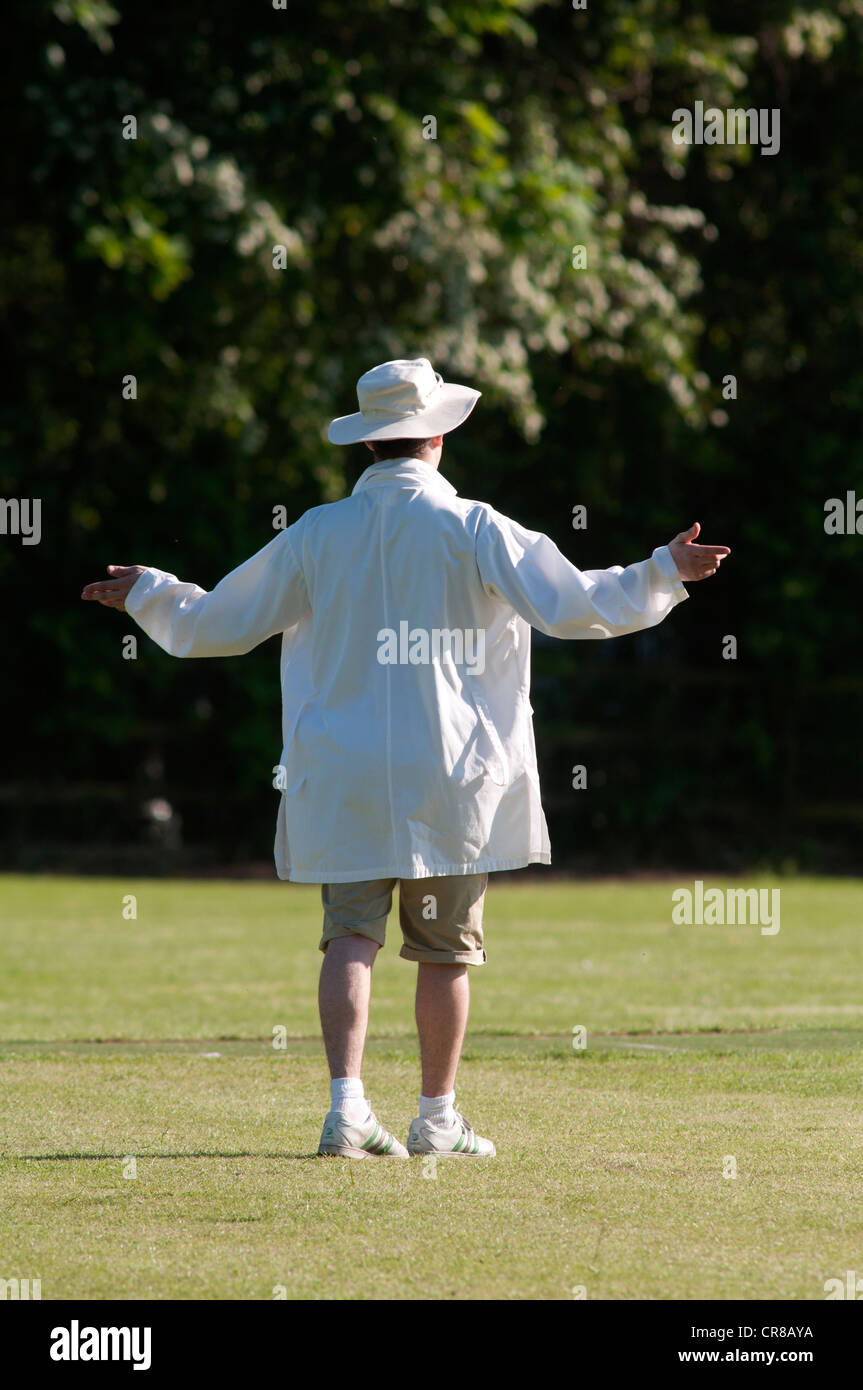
[477,509,689,638]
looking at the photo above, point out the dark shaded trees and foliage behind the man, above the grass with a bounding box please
[0,0,863,872]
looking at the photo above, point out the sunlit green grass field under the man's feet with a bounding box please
[0,874,863,1300]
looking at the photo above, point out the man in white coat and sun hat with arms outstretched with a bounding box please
[82,357,730,1158]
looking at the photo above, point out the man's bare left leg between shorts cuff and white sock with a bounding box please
[318,935,381,1080]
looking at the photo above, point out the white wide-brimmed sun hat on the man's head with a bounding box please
[327,357,482,443]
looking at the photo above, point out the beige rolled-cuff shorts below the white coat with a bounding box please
[320,873,488,965]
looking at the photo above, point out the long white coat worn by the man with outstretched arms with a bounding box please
[126,459,688,883]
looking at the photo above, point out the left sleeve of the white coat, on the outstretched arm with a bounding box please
[126,527,311,656]
